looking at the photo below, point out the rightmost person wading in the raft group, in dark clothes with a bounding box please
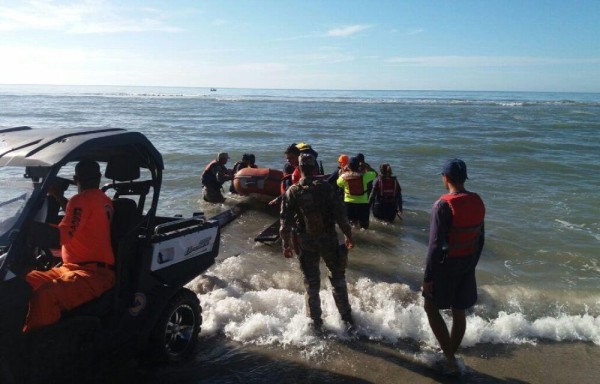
[369,164,402,223]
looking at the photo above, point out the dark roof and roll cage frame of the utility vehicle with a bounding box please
[0,126,164,277]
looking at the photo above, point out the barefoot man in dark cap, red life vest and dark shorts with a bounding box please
[423,159,485,374]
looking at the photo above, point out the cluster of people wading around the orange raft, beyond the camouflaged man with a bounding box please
[202,143,402,229]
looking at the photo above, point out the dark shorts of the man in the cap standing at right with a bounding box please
[423,257,477,309]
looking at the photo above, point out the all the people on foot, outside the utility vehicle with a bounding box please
[202,143,485,376]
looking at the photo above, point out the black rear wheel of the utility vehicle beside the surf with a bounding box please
[148,288,202,363]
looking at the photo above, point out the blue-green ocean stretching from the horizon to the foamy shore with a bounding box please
[0,85,600,382]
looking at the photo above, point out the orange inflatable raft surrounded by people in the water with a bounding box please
[233,168,283,197]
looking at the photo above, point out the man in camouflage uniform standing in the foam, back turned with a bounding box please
[279,153,354,331]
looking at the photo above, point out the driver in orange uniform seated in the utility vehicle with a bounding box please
[24,160,115,331]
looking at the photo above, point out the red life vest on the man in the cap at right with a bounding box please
[440,192,485,257]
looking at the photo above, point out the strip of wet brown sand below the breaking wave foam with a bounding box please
[135,337,600,384]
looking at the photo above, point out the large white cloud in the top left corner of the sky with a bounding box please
[0,0,180,33]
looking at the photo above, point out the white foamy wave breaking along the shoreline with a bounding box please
[189,256,600,356]
